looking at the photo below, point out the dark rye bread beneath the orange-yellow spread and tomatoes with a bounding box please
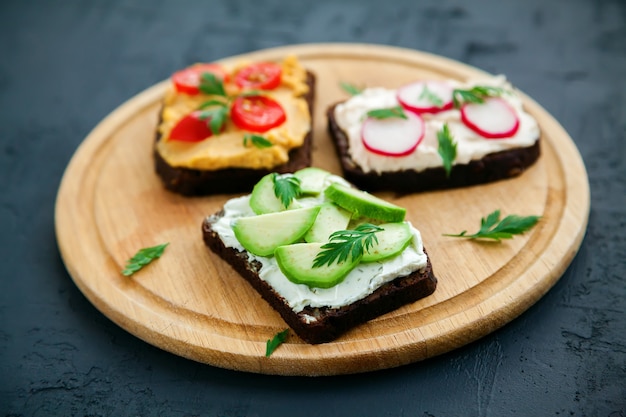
[154,71,315,196]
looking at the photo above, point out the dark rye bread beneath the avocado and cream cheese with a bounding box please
[202,212,437,344]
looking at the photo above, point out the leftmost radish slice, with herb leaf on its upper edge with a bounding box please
[361,112,425,156]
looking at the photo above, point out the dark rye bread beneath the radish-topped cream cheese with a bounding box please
[326,103,540,194]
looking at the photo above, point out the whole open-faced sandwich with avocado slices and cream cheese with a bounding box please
[202,167,437,343]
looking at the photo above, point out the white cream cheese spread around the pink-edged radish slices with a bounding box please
[335,76,539,173]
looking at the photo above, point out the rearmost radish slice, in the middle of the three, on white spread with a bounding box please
[397,81,454,114]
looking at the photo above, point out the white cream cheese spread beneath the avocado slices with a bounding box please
[212,188,427,312]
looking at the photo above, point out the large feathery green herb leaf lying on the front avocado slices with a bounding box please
[313,223,383,268]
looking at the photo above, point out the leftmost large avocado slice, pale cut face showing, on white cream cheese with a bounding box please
[232,206,320,256]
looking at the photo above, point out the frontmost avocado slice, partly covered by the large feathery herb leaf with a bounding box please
[274,242,360,288]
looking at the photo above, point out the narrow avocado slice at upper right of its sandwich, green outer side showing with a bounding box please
[324,183,406,223]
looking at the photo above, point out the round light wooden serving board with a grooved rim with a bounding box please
[55,44,589,375]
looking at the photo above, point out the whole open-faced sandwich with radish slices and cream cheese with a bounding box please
[327,76,540,193]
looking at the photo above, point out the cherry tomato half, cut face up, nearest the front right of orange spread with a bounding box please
[230,96,287,133]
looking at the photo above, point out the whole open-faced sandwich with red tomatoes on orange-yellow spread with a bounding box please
[154,56,315,195]
